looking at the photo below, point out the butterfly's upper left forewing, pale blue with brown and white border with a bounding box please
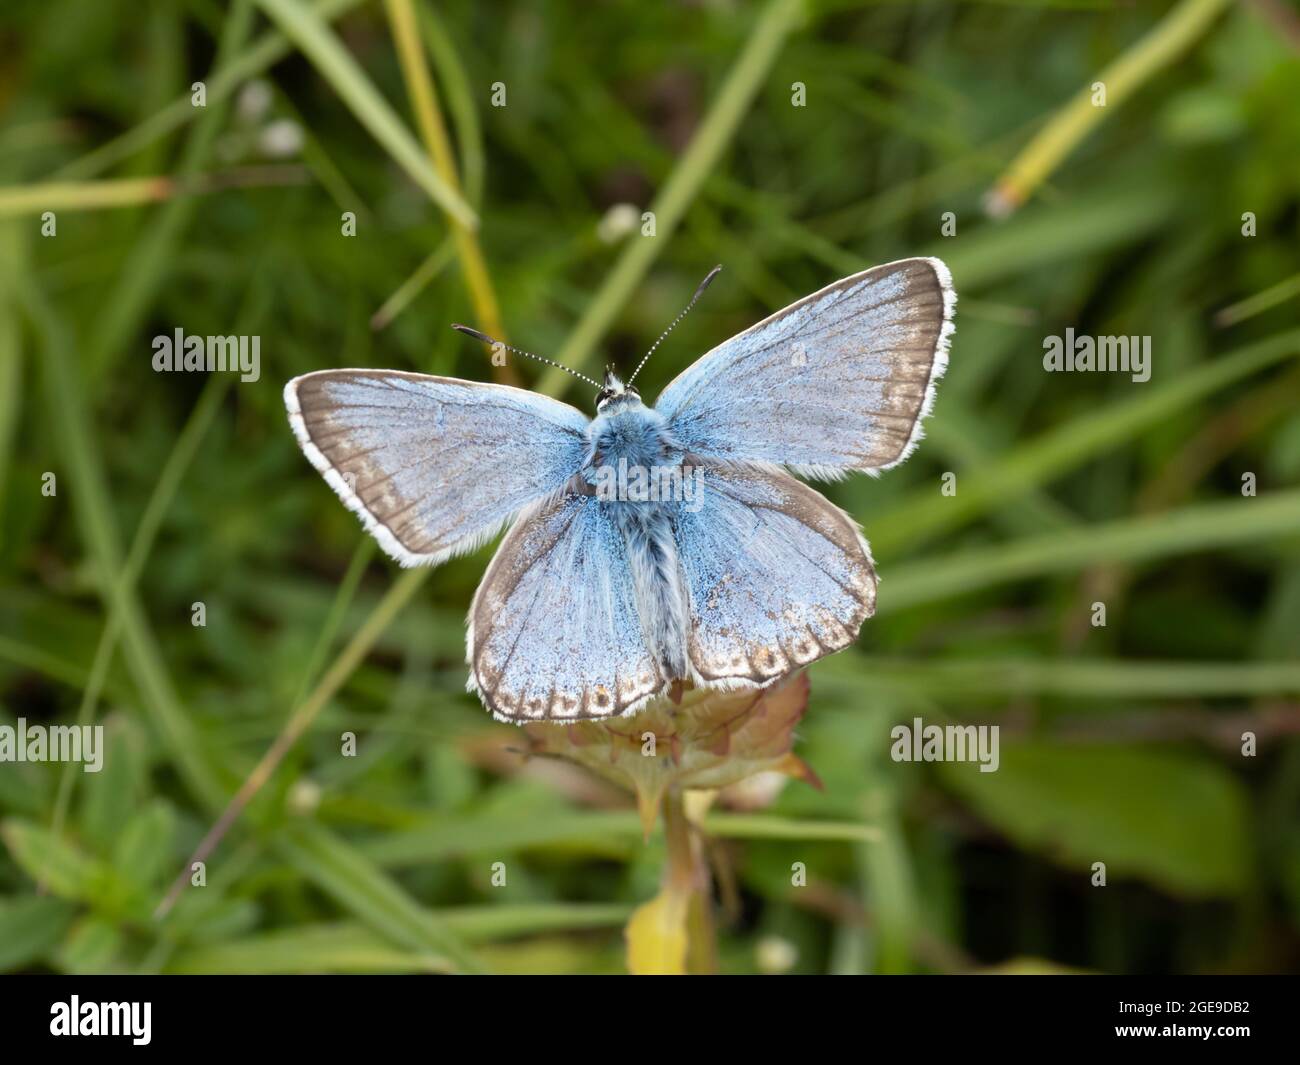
[285,369,588,566]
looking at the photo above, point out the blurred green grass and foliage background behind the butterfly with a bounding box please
[0,0,1300,973]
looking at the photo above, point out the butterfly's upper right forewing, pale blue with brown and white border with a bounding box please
[655,259,957,477]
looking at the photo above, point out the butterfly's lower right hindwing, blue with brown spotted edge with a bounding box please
[675,456,876,687]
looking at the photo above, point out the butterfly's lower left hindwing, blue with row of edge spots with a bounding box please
[467,493,666,722]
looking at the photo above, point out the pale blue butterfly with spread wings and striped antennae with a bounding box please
[285,259,957,723]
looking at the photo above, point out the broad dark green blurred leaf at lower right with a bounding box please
[936,743,1251,897]
